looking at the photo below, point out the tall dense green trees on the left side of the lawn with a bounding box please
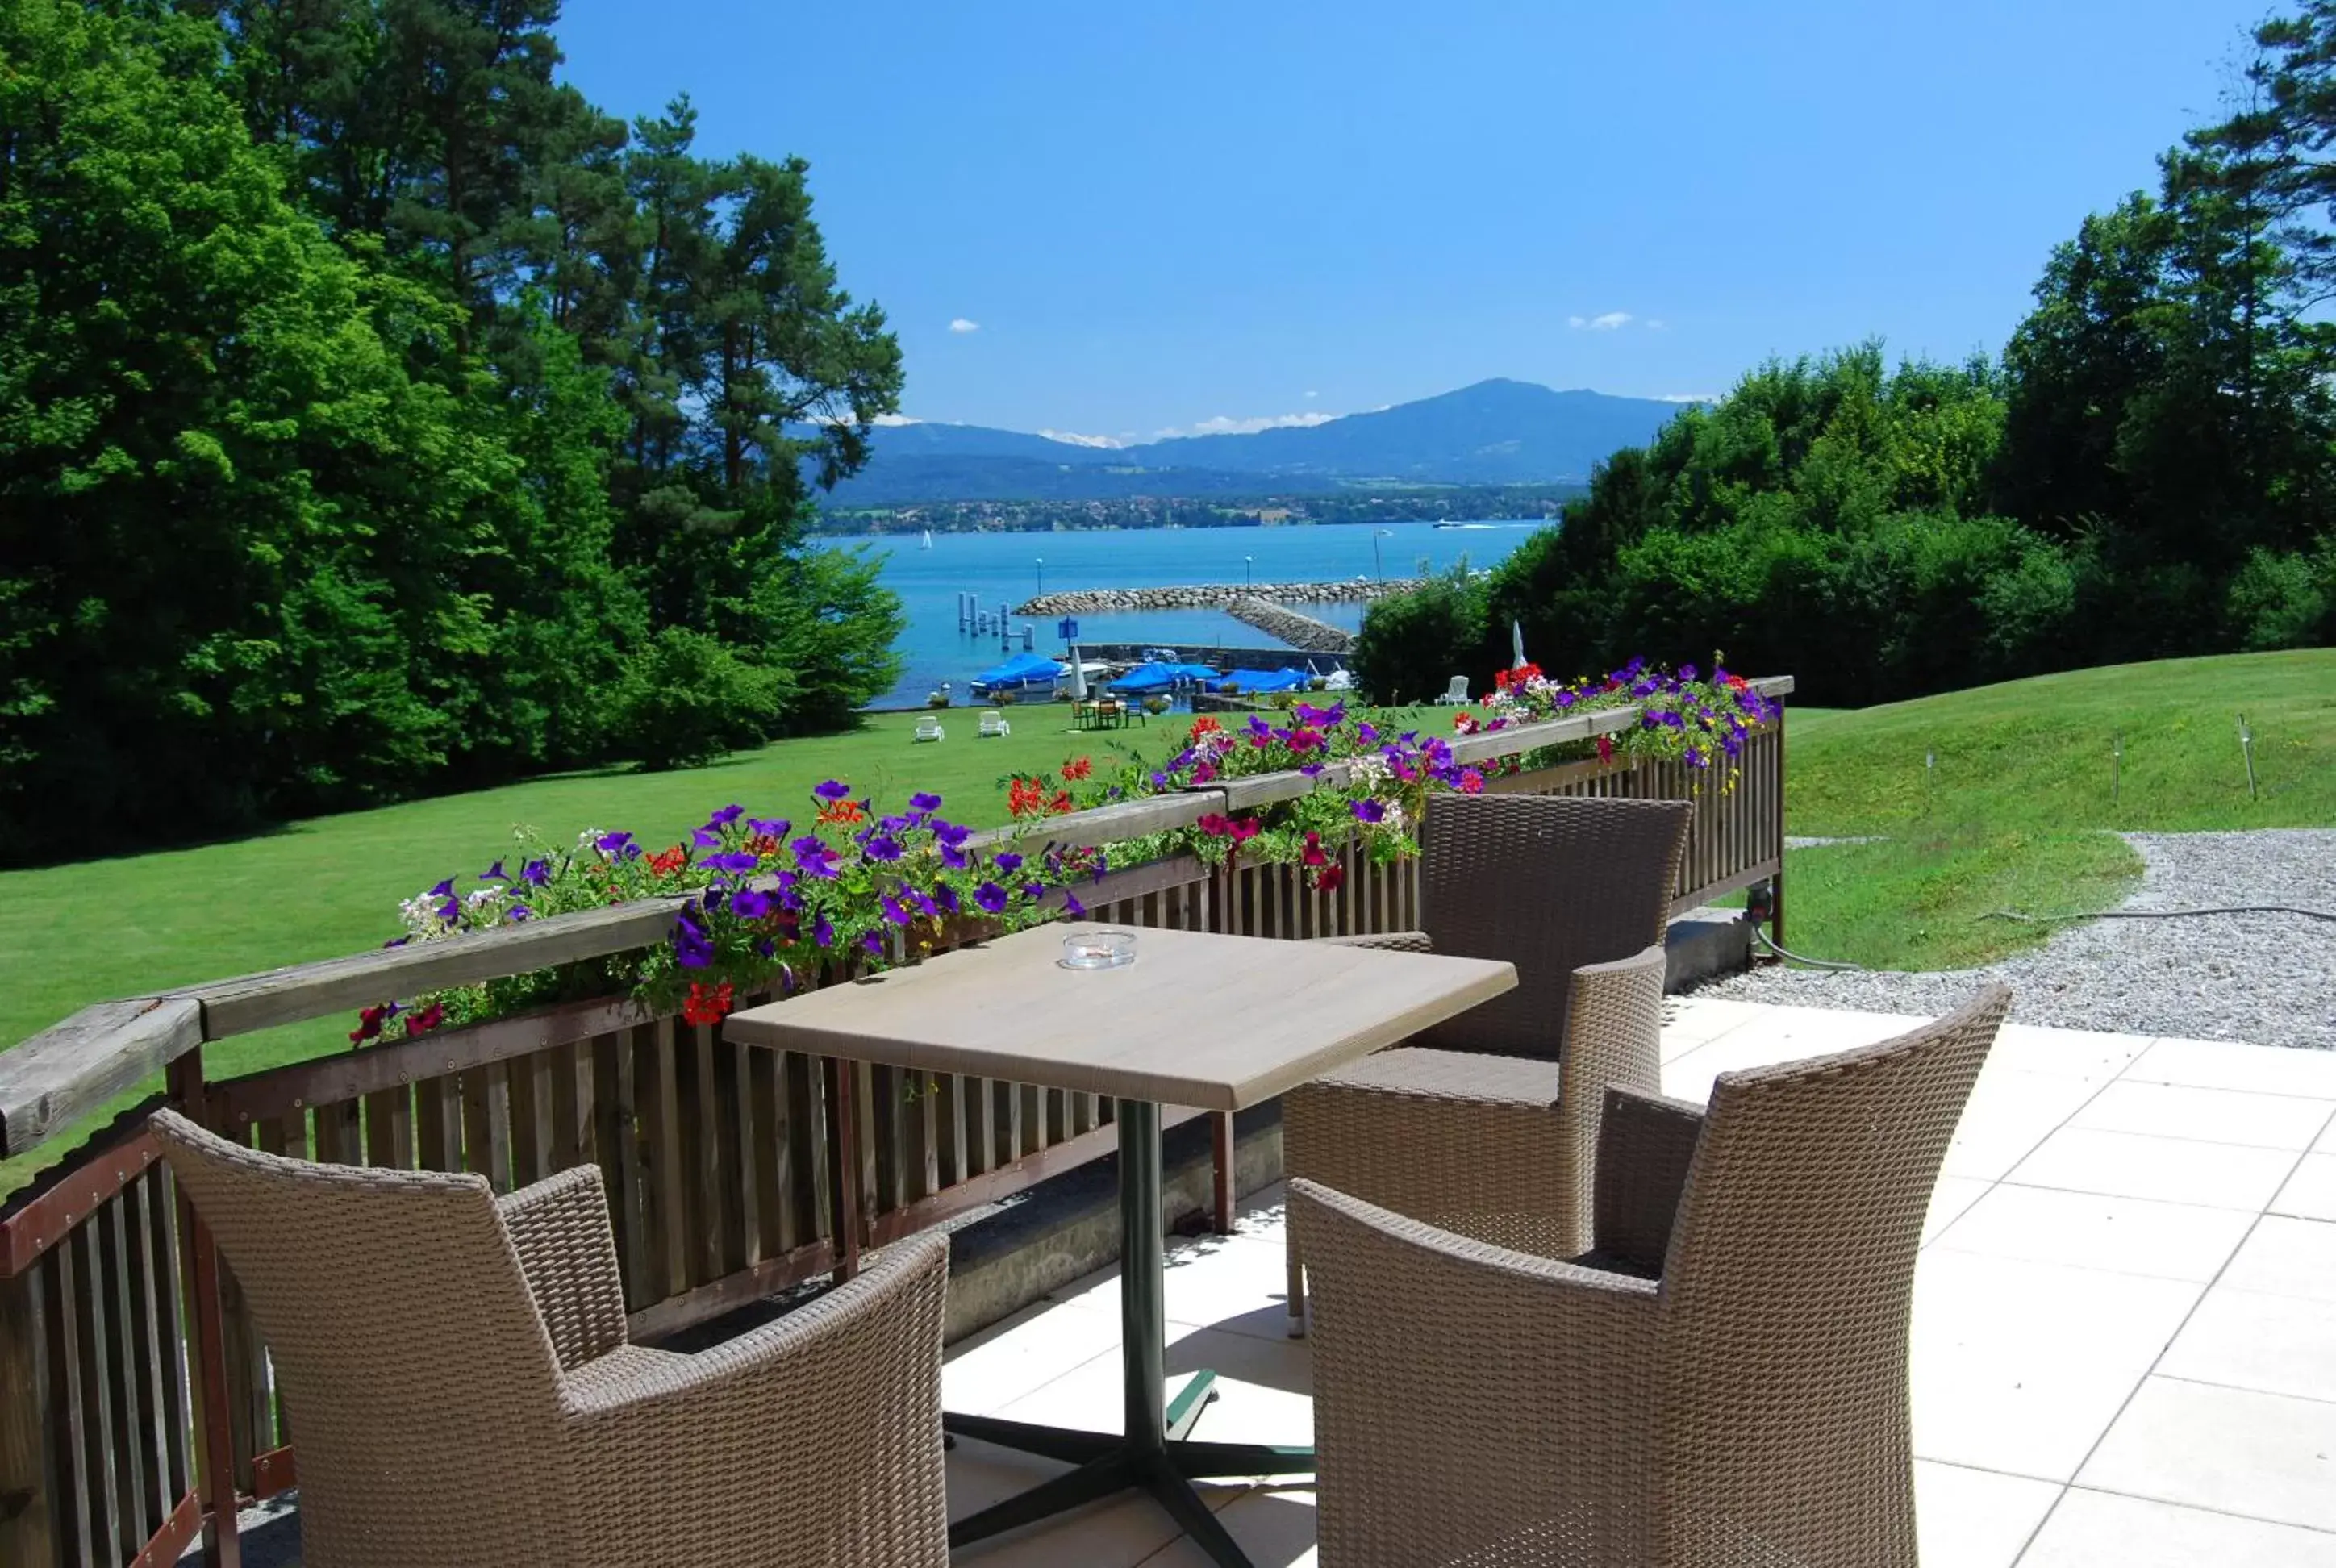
[0,0,899,860]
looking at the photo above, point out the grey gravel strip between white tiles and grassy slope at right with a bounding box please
[1698,828,2336,1052]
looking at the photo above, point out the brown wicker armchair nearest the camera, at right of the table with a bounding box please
[1290,986,2011,1568]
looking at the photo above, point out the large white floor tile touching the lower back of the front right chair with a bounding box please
[1911,1248,2200,1482]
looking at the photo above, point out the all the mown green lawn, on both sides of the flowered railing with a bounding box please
[0,649,2336,1192]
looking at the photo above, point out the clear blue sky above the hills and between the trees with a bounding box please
[561,0,2263,440]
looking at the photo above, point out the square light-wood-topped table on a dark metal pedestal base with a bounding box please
[724,925,1516,1568]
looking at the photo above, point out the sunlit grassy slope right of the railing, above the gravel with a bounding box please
[1785,649,2336,967]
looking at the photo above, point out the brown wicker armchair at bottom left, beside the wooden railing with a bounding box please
[154,1110,949,1568]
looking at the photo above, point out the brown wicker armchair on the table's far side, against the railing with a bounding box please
[1283,794,1694,1334]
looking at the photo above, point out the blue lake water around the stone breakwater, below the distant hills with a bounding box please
[820,523,1541,708]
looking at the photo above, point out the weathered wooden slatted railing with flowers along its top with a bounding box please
[0,680,1789,1568]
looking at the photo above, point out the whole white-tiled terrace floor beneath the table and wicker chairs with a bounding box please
[946,1000,2336,1568]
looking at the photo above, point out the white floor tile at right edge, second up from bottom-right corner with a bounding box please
[2079,1376,2336,1531]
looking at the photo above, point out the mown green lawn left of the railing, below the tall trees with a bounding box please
[0,703,1432,1194]
